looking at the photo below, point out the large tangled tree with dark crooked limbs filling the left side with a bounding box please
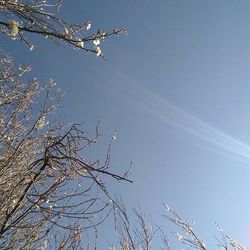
[0,52,130,249]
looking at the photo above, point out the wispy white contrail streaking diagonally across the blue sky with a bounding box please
[105,65,250,164]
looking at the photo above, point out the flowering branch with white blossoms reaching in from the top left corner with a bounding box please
[0,0,126,57]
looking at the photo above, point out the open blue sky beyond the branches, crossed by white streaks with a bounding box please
[1,0,250,248]
